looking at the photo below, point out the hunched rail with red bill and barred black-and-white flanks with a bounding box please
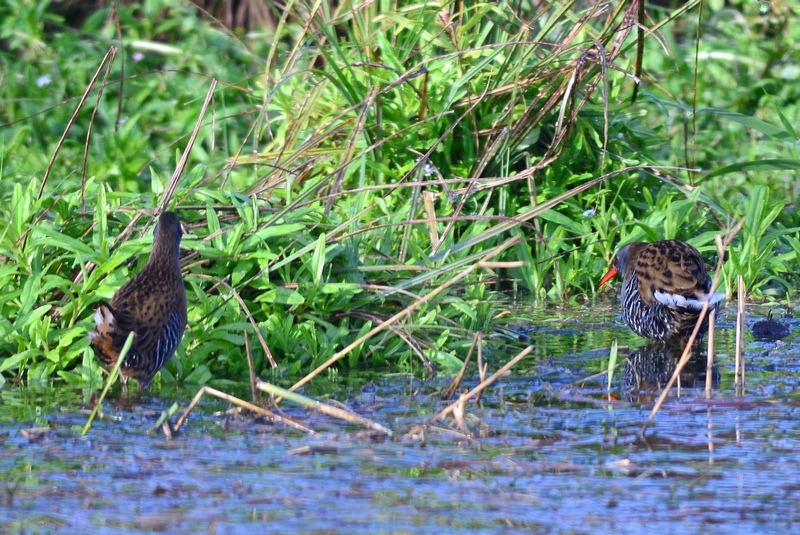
[597,240,725,341]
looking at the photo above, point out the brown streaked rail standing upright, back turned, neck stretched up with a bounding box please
[89,212,186,389]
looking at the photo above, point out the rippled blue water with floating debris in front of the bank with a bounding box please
[0,308,800,534]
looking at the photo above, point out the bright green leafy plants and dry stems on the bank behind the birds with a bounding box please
[0,0,800,384]
